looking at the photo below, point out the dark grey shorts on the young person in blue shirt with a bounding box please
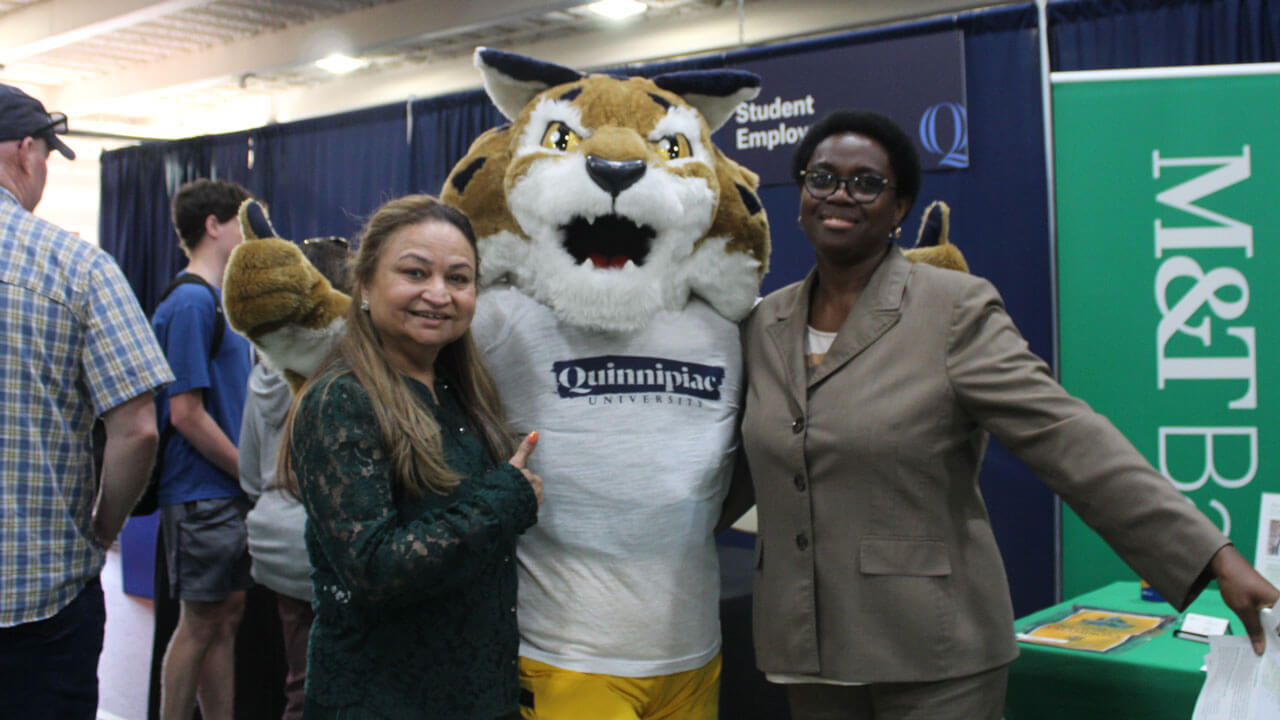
[160,497,253,602]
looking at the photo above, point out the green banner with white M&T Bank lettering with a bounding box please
[1053,65,1280,597]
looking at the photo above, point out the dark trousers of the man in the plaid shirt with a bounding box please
[0,578,104,720]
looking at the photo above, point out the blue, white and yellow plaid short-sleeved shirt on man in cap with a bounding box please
[0,187,173,626]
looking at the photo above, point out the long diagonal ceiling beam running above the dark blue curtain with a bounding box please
[46,0,581,109]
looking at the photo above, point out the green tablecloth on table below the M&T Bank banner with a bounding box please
[1005,580,1244,720]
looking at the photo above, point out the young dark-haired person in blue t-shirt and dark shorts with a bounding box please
[152,179,253,720]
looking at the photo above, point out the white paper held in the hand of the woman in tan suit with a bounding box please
[1192,610,1280,720]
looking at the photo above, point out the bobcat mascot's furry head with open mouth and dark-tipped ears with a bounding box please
[442,47,769,331]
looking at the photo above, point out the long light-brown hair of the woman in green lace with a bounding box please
[279,195,515,498]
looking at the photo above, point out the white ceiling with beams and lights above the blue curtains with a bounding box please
[0,0,1004,137]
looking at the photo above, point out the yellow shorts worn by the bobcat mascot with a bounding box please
[520,655,721,720]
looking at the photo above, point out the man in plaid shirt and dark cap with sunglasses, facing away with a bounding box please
[0,83,173,720]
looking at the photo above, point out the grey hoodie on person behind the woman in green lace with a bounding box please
[239,363,312,602]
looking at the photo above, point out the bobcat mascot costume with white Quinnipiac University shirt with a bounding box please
[224,49,954,719]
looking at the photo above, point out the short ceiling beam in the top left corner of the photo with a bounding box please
[0,0,209,64]
